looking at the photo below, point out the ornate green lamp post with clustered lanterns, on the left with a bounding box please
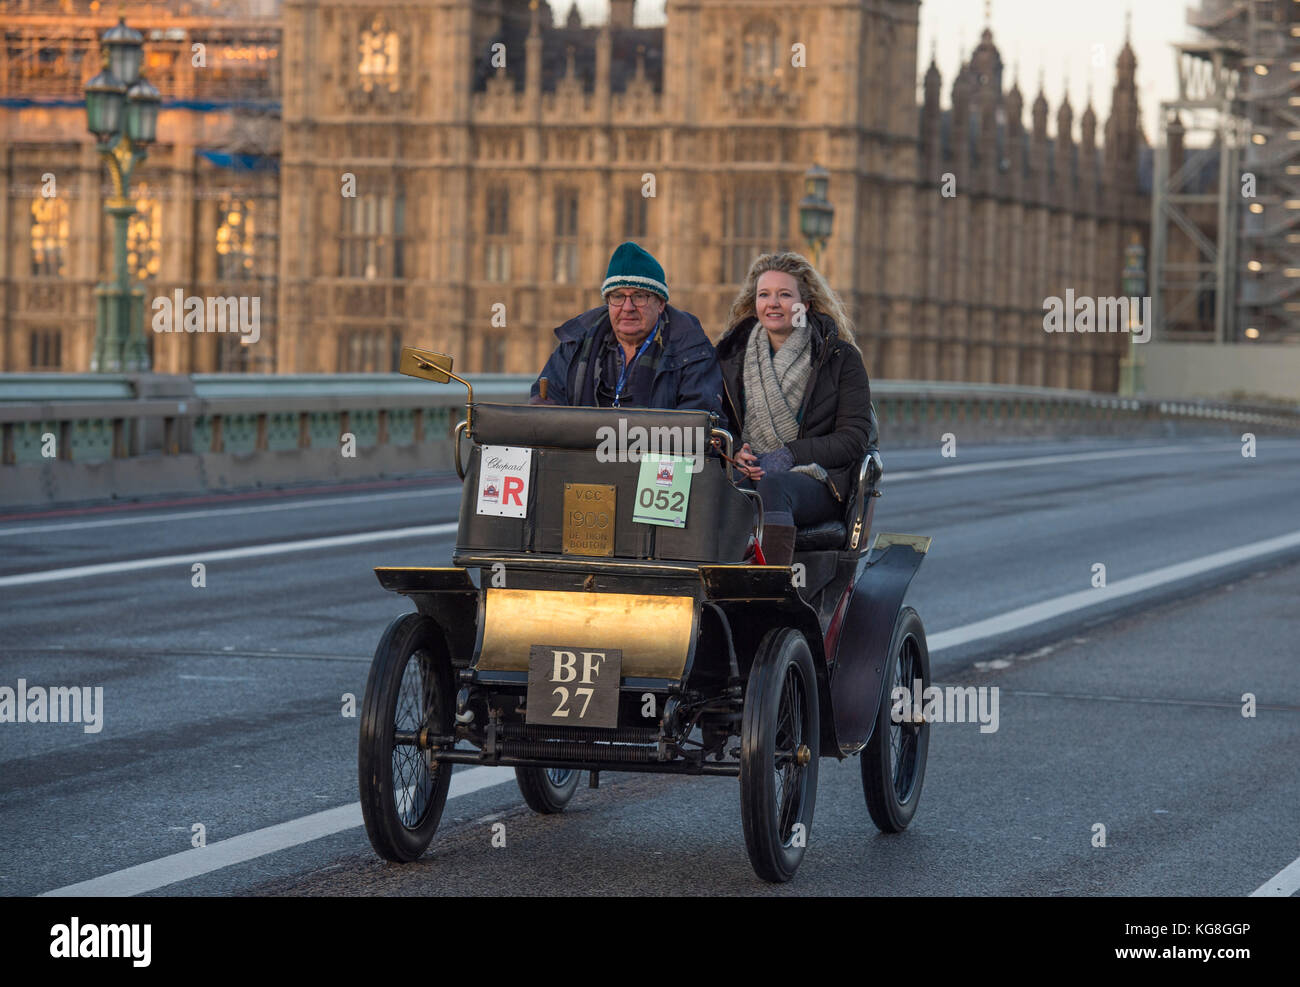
[86,20,161,373]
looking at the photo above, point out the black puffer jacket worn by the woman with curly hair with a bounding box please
[718,312,871,501]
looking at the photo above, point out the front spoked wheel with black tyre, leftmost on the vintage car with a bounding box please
[356,614,455,863]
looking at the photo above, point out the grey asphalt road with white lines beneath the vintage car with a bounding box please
[0,438,1300,896]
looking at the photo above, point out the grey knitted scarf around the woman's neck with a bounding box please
[741,322,826,482]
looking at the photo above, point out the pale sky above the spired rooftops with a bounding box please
[572,0,1199,143]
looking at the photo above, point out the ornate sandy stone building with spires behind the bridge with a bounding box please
[0,0,1149,390]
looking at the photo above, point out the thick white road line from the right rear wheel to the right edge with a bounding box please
[928,531,1300,654]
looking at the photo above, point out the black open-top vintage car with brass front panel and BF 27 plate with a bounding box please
[358,349,931,882]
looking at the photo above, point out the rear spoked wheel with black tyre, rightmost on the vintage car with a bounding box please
[862,606,931,832]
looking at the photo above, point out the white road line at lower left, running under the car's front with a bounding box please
[42,767,515,897]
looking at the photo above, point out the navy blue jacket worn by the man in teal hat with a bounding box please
[532,299,727,428]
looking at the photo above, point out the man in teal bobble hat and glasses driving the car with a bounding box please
[529,241,727,428]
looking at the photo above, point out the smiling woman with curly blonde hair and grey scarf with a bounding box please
[718,252,871,566]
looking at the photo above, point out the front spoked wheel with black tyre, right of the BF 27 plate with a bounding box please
[740,627,822,883]
